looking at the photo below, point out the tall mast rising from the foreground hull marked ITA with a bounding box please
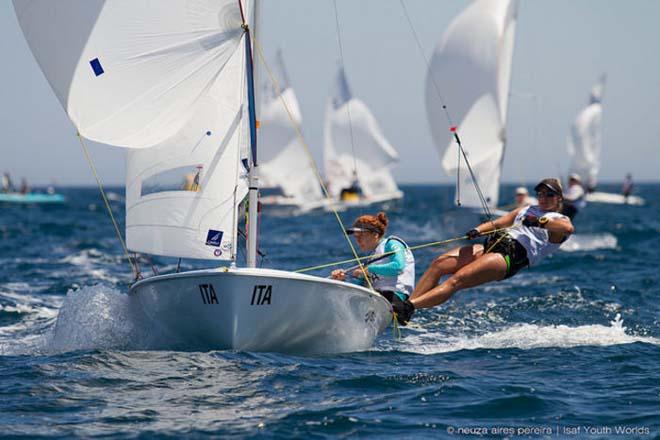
[245,0,259,267]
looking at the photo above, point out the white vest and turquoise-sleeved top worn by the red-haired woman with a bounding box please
[360,235,415,302]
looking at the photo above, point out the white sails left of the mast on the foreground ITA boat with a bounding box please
[14,0,250,259]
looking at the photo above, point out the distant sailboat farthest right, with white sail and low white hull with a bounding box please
[567,75,644,205]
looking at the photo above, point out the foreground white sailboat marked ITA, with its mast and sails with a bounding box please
[13,0,391,353]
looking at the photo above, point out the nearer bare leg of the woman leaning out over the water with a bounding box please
[411,253,506,309]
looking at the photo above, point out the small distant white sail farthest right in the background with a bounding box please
[567,75,605,189]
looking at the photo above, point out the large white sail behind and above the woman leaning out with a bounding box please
[426,0,517,208]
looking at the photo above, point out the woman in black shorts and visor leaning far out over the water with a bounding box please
[394,178,573,322]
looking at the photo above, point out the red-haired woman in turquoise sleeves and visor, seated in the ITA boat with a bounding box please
[331,212,415,322]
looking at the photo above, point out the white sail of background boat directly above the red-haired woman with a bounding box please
[323,68,399,197]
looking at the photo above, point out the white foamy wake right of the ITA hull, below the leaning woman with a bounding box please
[390,314,660,354]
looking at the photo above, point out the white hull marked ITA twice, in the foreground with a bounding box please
[129,268,392,354]
